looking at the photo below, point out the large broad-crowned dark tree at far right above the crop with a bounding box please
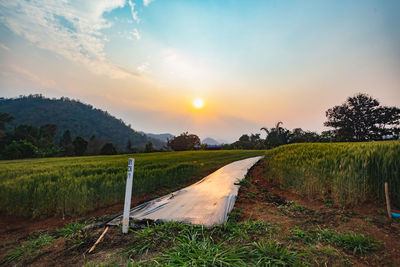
[324,93,400,141]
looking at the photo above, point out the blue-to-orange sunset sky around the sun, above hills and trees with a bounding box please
[0,0,400,142]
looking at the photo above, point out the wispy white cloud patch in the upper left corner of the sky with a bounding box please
[0,0,137,78]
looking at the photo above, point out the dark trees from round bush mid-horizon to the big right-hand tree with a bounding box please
[168,93,400,150]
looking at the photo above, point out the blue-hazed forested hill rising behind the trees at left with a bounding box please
[0,95,163,150]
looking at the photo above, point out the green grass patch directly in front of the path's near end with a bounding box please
[123,221,308,266]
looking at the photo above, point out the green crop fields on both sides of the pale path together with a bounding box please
[0,141,400,217]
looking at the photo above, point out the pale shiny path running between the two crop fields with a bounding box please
[109,157,262,226]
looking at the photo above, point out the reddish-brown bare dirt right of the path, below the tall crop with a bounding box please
[235,160,400,266]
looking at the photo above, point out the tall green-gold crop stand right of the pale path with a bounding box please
[265,141,400,207]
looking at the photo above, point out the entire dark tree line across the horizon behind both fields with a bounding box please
[0,94,400,159]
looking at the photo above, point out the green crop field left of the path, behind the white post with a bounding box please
[0,150,265,217]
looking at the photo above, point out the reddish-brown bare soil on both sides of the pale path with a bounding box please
[0,160,400,266]
